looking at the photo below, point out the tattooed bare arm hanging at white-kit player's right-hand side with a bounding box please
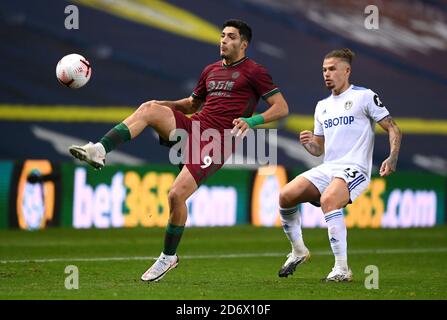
[379,116,402,177]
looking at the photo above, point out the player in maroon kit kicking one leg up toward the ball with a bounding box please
[69,19,288,281]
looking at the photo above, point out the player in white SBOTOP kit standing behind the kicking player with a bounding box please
[279,49,402,282]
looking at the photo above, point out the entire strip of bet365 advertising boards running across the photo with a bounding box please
[0,160,447,230]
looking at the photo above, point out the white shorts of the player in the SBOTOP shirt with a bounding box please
[300,163,370,204]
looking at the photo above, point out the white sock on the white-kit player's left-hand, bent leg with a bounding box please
[279,207,307,256]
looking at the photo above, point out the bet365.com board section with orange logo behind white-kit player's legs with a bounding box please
[251,169,446,228]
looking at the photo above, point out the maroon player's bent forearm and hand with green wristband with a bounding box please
[232,92,289,136]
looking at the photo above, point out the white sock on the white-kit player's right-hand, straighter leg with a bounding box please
[324,209,348,270]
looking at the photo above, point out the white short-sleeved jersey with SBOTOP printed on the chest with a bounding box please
[314,85,389,177]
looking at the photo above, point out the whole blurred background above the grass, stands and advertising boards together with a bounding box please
[0,0,447,300]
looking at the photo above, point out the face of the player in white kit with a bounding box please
[323,58,351,91]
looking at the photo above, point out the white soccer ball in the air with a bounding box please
[56,53,92,89]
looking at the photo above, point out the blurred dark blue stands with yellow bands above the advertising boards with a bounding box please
[0,0,447,174]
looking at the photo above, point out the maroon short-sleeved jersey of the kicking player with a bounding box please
[191,57,279,132]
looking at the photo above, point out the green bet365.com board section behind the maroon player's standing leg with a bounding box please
[58,164,251,228]
